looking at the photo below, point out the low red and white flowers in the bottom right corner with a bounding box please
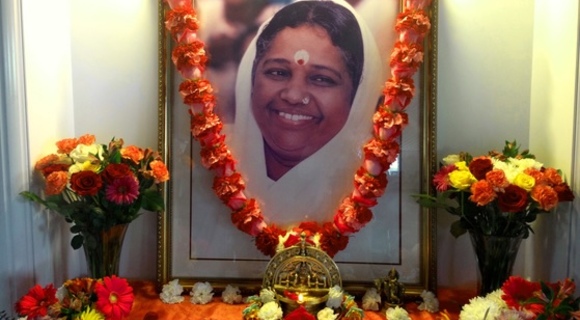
[459,276,580,320]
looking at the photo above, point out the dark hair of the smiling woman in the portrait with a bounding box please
[252,1,364,102]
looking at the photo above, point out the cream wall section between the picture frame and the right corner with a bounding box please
[437,0,534,288]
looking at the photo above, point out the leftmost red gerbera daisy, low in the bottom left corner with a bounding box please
[15,284,58,319]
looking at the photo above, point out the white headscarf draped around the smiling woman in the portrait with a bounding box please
[228,0,384,226]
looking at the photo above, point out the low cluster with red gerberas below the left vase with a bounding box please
[15,276,135,320]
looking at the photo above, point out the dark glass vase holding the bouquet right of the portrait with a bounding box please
[469,231,523,296]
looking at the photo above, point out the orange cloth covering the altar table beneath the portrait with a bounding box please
[127,281,473,320]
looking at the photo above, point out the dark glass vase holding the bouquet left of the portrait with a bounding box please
[83,224,129,279]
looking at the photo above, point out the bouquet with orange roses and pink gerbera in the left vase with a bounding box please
[21,134,169,249]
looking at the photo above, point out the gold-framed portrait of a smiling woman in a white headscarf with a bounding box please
[158,0,437,295]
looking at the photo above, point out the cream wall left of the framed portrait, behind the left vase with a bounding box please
[0,0,158,316]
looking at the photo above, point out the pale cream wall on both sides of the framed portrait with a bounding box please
[0,0,580,310]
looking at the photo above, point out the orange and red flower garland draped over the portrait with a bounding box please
[165,0,431,257]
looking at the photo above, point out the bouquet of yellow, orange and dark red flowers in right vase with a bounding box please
[415,141,574,238]
